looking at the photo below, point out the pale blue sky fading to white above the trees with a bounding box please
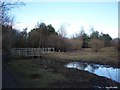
[11,2,118,38]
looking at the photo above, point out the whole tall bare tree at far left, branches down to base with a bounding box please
[0,0,25,51]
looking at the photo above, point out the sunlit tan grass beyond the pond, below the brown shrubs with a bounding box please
[44,47,118,66]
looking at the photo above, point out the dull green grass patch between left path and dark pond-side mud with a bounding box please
[9,59,66,88]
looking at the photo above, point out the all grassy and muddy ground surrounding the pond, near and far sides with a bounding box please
[5,47,118,88]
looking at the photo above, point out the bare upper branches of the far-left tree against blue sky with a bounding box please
[0,0,25,25]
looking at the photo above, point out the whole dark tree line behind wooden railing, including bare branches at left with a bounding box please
[0,2,118,51]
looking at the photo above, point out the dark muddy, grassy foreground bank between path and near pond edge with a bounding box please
[8,58,120,88]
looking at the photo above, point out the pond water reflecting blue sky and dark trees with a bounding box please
[65,62,120,83]
